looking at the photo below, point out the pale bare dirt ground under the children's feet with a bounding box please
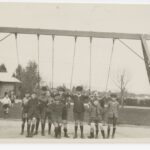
[0,119,150,142]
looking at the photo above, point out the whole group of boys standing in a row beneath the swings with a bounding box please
[21,86,119,138]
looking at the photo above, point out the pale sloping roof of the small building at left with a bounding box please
[0,72,20,83]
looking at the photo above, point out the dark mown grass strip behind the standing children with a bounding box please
[0,103,150,126]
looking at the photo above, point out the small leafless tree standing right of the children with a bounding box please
[113,69,130,107]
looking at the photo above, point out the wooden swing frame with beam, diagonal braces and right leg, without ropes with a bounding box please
[0,27,150,86]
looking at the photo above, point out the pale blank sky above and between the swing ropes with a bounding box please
[0,3,150,94]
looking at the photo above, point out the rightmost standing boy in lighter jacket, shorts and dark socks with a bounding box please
[107,94,119,138]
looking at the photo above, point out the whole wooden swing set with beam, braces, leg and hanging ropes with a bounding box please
[0,27,150,92]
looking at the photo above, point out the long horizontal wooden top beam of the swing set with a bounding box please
[0,27,150,40]
